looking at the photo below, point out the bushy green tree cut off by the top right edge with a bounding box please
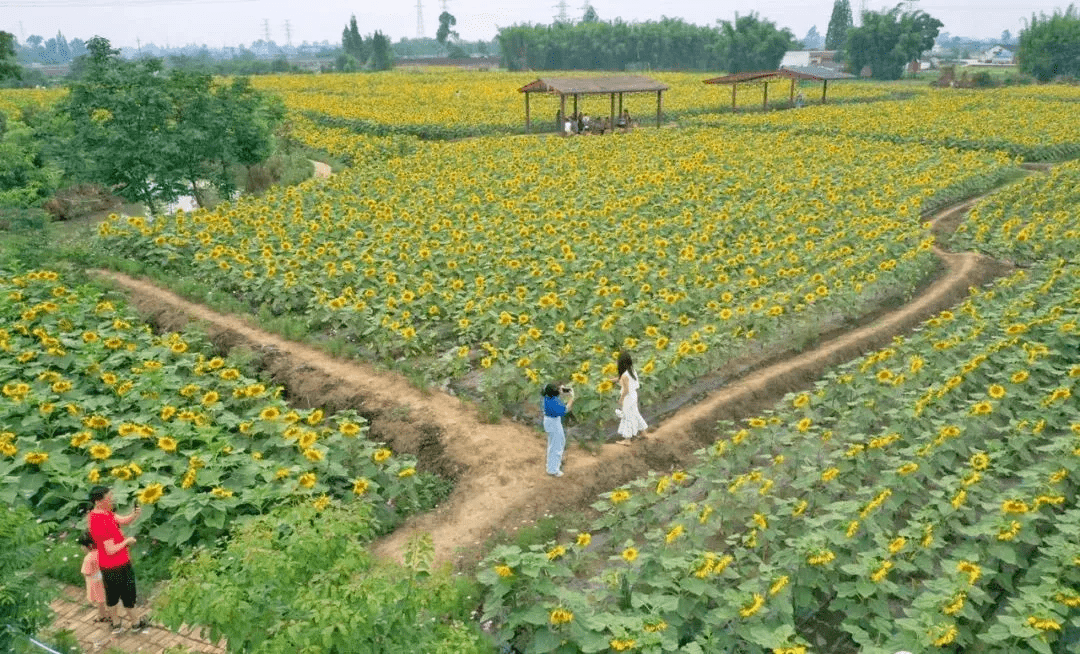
[1016,4,1080,82]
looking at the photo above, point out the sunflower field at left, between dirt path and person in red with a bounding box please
[0,271,429,545]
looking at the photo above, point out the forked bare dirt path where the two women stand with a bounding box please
[98,184,1003,564]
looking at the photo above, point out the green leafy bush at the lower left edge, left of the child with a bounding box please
[0,506,52,652]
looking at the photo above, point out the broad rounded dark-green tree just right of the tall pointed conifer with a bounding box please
[847,4,942,80]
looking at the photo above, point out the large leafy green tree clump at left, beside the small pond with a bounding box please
[60,37,281,214]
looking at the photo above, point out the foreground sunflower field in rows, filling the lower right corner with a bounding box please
[478,164,1080,654]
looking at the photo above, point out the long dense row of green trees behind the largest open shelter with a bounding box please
[498,13,796,72]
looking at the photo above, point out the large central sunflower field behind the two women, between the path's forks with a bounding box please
[99,128,1014,421]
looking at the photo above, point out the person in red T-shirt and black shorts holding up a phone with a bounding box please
[86,486,148,632]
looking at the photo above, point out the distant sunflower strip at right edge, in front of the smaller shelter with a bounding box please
[693,86,1080,161]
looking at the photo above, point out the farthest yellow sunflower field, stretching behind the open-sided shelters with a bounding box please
[252,69,911,139]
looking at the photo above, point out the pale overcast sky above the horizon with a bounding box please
[0,0,1068,46]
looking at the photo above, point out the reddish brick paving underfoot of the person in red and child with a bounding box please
[42,586,226,654]
